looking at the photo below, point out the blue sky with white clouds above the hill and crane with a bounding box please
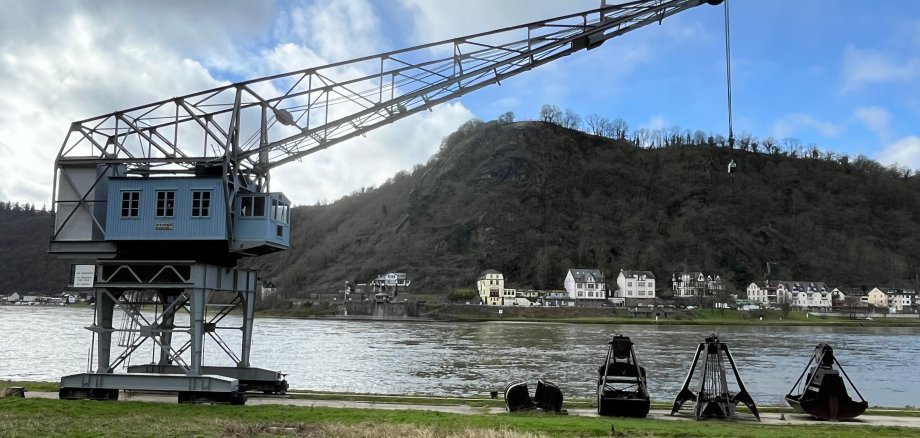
[0,0,920,208]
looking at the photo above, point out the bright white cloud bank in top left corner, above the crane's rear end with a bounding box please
[0,3,229,204]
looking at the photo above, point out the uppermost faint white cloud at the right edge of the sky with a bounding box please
[843,46,920,91]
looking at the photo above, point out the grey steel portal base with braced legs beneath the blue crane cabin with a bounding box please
[61,261,287,400]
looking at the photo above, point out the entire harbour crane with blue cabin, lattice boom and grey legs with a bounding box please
[49,0,722,403]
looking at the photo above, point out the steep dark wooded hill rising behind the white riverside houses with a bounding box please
[244,122,920,295]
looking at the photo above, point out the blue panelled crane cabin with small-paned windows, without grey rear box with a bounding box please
[105,176,290,265]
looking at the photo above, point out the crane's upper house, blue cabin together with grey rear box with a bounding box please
[51,160,291,266]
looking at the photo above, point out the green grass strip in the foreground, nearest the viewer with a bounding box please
[0,397,918,438]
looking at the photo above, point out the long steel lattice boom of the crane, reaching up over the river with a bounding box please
[58,0,718,190]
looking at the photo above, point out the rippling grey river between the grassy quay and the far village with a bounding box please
[0,306,920,407]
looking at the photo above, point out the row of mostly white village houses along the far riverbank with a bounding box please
[0,268,920,318]
